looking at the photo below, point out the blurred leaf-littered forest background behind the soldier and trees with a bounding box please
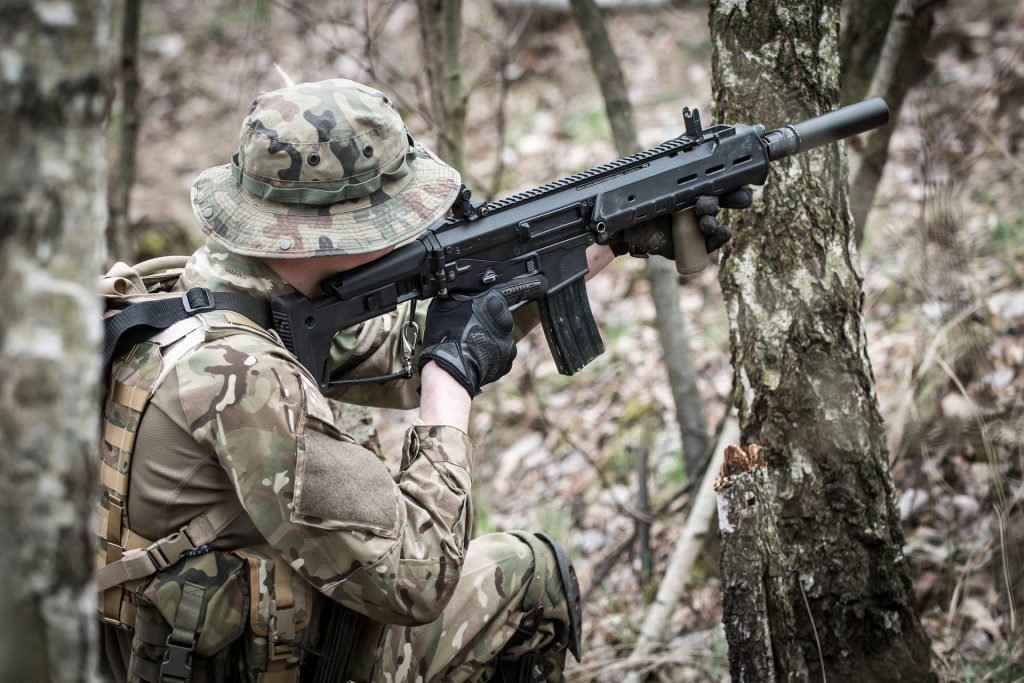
[97,0,1024,681]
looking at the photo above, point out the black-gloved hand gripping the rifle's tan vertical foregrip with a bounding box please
[608,187,754,259]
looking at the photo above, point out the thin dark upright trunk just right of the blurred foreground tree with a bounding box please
[108,0,142,263]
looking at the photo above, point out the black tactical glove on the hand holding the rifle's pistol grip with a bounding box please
[420,290,515,396]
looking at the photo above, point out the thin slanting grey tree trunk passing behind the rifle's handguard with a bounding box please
[570,0,708,474]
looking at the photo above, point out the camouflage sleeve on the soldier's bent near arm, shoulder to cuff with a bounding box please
[176,338,473,625]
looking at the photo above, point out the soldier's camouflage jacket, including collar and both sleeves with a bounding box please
[136,244,473,625]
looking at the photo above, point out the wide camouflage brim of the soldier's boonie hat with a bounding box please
[191,144,461,258]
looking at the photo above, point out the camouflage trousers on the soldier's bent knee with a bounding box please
[372,531,569,683]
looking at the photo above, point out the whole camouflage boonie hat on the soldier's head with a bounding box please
[191,79,461,258]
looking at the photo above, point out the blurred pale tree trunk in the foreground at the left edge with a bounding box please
[0,0,110,681]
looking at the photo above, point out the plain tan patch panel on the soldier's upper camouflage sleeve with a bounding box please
[291,374,401,538]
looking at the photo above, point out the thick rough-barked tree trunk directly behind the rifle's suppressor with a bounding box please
[711,0,935,682]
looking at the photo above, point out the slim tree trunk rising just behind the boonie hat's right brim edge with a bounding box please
[418,0,466,173]
